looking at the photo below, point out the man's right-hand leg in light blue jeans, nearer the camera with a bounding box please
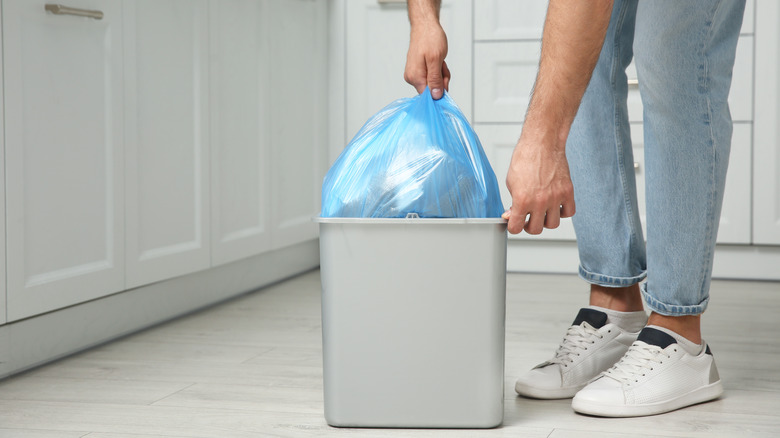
[634,0,745,342]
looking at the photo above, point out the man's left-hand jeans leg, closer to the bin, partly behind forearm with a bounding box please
[566,1,646,298]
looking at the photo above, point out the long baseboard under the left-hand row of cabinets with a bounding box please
[0,240,319,379]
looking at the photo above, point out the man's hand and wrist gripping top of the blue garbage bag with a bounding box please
[404,0,450,99]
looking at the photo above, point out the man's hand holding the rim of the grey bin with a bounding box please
[503,133,575,234]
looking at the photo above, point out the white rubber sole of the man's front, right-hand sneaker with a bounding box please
[571,380,723,417]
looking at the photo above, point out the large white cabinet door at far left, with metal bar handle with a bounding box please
[3,0,124,321]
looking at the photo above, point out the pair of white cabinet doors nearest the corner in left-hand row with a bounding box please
[210,0,328,265]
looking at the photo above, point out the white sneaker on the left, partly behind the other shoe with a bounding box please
[515,308,638,399]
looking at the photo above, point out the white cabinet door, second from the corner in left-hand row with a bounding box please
[209,0,272,265]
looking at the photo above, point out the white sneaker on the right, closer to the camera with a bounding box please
[572,326,723,417]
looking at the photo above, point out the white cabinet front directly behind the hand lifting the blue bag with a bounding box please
[344,0,473,139]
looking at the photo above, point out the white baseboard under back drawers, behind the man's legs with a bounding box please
[507,239,780,280]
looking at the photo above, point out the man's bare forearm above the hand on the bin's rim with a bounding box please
[523,0,613,147]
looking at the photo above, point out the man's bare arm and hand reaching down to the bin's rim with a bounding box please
[504,0,613,234]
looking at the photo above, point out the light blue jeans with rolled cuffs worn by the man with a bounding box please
[566,0,745,316]
